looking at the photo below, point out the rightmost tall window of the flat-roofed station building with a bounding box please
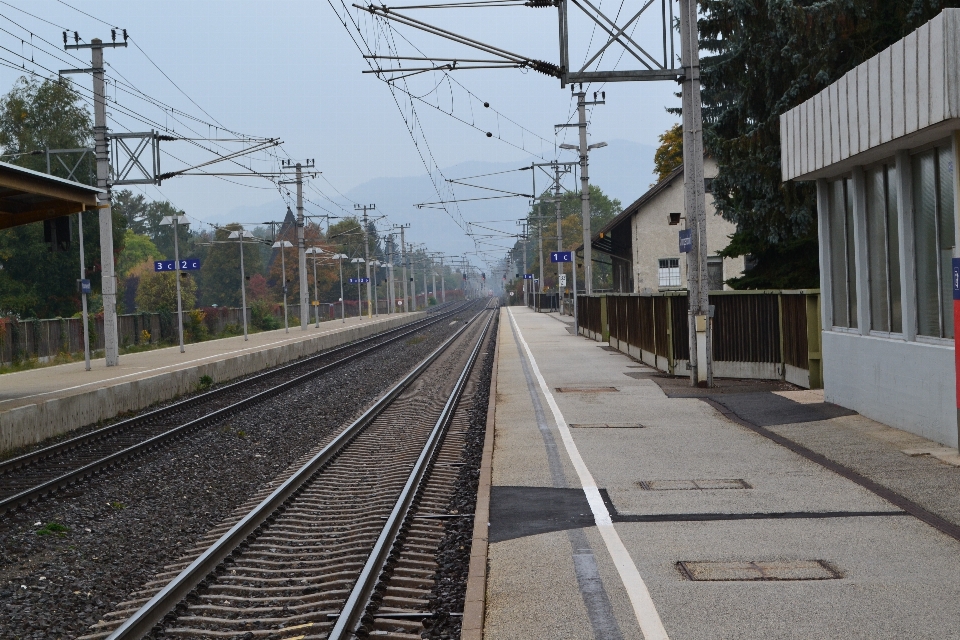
[911,145,955,338]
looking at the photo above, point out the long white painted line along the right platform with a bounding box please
[507,308,668,640]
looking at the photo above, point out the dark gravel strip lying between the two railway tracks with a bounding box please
[0,306,472,639]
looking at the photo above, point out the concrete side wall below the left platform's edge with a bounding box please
[0,313,424,451]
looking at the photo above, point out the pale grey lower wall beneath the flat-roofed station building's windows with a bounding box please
[823,331,957,447]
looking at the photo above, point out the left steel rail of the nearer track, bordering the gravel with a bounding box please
[107,310,496,640]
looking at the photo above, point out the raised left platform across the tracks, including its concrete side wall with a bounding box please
[0,312,423,453]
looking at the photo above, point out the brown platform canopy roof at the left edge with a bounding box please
[0,162,106,229]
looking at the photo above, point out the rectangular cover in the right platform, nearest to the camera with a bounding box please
[677,560,843,582]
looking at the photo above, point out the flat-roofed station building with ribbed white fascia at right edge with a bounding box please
[780,9,960,447]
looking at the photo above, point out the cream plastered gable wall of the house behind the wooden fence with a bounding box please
[631,158,743,293]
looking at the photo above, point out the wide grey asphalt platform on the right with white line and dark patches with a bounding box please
[474,307,960,640]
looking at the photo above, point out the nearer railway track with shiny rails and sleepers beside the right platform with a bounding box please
[84,308,496,640]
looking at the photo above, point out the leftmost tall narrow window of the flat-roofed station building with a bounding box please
[829,178,857,328]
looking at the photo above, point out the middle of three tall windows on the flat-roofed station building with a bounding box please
[866,165,903,333]
